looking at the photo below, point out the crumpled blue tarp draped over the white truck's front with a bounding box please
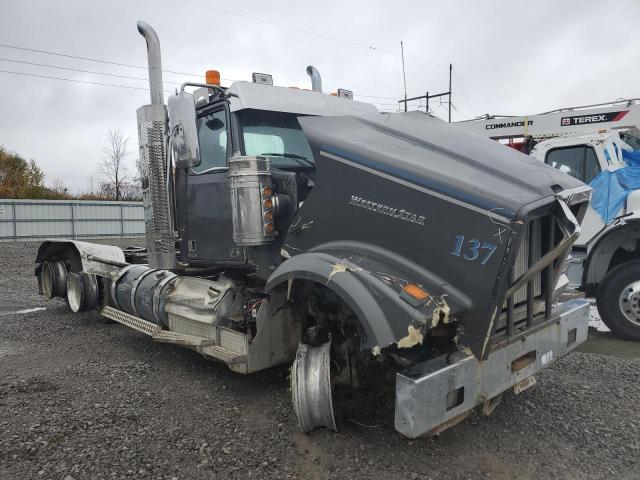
[589,150,640,224]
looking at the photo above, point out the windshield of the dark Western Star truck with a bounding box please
[238,110,314,167]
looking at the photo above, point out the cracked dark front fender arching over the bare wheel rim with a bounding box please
[266,242,470,350]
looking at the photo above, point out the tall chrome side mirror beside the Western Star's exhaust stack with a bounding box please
[167,92,200,168]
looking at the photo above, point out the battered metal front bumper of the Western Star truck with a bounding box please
[395,300,589,438]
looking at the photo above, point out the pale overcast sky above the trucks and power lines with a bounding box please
[0,0,640,193]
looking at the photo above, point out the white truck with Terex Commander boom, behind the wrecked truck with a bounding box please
[458,99,640,341]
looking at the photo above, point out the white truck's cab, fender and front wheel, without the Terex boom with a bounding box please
[531,128,640,340]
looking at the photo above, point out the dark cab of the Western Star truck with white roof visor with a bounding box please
[173,81,377,272]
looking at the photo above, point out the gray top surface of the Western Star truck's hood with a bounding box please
[299,112,583,219]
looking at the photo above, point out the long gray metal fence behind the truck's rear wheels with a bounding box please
[0,199,144,241]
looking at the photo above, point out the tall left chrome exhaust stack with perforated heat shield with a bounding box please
[136,21,176,269]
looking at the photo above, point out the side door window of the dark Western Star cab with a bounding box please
[192,110,228,173]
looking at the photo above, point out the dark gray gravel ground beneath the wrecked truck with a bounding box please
[0,242,640,480]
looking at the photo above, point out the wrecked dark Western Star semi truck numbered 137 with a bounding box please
[35,22,590,438]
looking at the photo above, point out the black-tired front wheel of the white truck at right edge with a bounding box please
[596,260,640,341]
